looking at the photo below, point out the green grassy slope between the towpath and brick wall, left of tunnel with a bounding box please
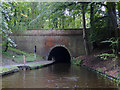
[2,47,42,63]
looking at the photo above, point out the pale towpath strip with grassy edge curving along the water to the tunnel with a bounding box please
[0,60,53,76]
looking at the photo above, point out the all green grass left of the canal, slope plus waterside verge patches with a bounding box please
[0,47,42,73]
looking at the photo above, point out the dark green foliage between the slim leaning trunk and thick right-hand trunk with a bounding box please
[89,3,114,43]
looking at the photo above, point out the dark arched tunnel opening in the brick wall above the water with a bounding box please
[48,46,71,63]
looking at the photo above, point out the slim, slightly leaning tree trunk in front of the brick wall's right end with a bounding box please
[82,3,90,55]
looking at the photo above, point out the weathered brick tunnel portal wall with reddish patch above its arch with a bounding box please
[11,30,85,61]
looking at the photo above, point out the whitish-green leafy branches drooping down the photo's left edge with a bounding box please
[0,3,16,52]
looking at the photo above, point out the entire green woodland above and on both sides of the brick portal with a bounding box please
[0,2,120,55]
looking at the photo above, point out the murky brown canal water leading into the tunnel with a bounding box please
[2,63,117,88]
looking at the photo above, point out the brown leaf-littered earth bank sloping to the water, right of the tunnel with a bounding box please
[74,52,120,86]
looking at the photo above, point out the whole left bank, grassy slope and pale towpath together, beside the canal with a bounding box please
[0,47,53,76]
